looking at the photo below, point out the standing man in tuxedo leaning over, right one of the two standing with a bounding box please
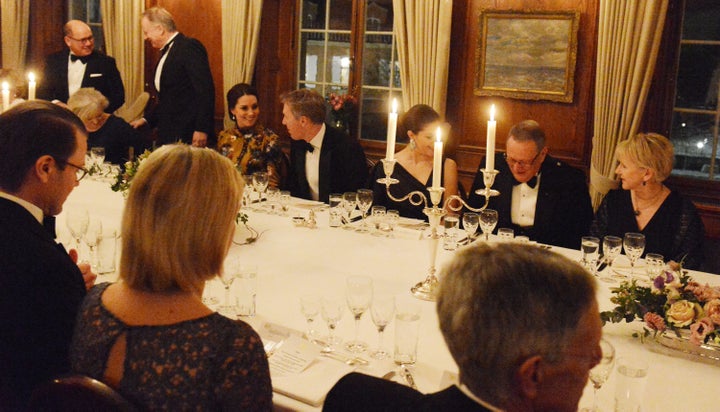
[131,7,215,147]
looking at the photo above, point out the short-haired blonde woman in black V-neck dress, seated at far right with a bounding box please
[590,133,705,269]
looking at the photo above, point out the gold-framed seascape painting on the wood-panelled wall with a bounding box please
[474,10,580,103]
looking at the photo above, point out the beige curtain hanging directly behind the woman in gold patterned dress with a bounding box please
[221,0,262,128]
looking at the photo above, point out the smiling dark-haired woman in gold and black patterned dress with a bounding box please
[217,83,287,188]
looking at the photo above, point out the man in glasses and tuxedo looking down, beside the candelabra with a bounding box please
[468,120,593,249]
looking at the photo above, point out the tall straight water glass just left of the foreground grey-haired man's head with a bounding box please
[393,297,421,365]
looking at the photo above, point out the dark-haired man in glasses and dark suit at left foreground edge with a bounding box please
[0,100,95,410]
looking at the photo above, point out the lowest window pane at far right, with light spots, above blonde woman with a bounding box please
[670,112,719,179]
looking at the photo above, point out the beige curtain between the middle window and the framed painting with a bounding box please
[393,0,452,115]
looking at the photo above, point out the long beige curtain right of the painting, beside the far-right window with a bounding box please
[590,0,668,208]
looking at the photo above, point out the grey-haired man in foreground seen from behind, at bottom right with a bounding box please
[323,242,602,412]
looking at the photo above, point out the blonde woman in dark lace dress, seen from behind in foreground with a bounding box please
[70,145,272,411]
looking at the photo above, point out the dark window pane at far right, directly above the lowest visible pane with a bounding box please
[675,44,720,110]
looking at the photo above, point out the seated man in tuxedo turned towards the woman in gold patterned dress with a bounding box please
[280,89,368,203]
